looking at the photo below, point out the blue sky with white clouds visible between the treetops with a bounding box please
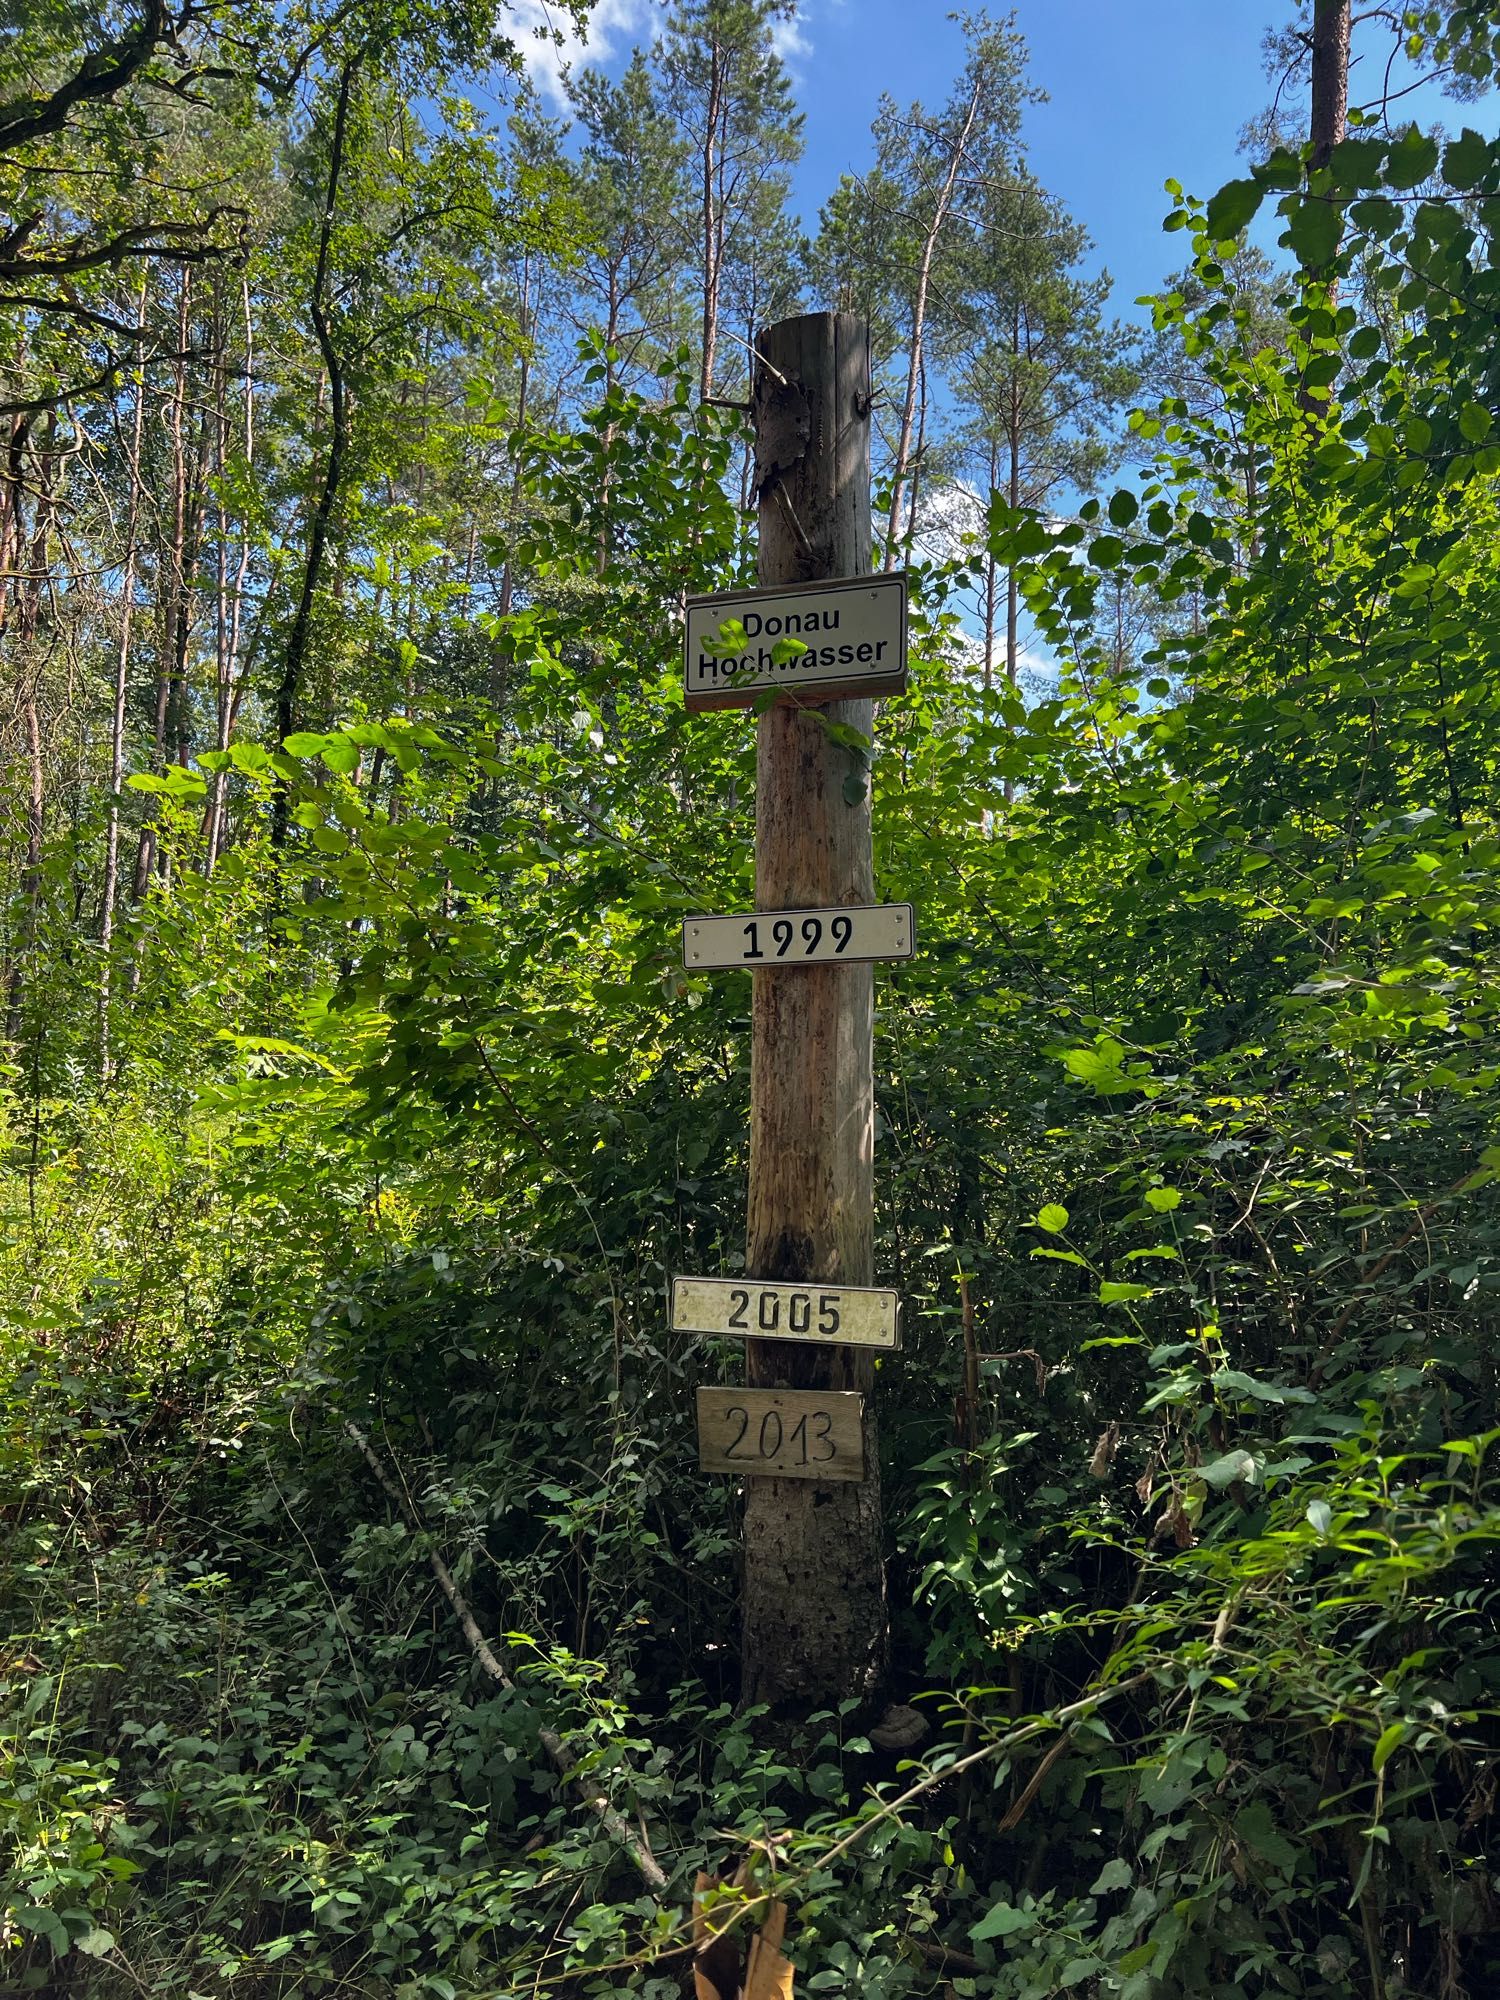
[514,0,1496,336]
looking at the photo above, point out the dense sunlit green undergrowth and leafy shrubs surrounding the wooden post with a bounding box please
[0,10,1500,2000]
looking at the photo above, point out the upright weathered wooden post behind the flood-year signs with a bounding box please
[744,312,888,1706]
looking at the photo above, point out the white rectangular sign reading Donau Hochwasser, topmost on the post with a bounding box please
[684,570,906,710]
